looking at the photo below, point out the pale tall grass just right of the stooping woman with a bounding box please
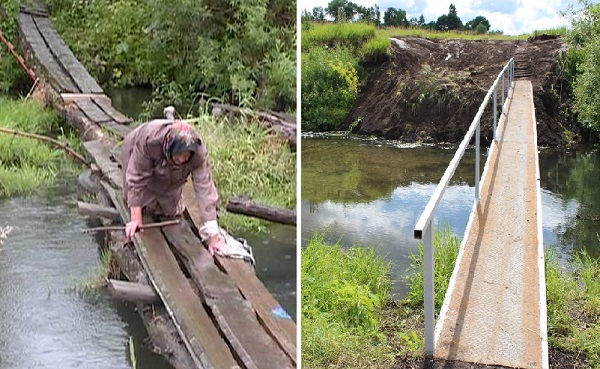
[188,114,296,231]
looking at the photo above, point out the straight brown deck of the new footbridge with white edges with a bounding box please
[434,81,548,369]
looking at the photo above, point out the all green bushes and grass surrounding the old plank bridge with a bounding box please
[0,0,296,232]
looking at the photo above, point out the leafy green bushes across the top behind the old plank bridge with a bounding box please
[47,0,296,111]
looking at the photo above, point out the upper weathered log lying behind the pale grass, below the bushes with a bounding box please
[212,104,296,150]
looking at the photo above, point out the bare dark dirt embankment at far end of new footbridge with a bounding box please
[341,36,581,146]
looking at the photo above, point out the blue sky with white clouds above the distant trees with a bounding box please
[298,0,578,35]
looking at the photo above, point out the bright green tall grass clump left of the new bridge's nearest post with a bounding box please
[301,232,394,368]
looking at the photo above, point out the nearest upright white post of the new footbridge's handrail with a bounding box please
[423,219,435,357]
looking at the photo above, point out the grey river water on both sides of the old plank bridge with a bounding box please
[0,89,296,369]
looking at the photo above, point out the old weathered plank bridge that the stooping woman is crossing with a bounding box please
[18,7,296,369]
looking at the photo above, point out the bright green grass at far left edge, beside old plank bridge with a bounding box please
[0,97,78,197]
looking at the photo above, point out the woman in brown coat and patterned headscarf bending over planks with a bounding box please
[121,113,225,255]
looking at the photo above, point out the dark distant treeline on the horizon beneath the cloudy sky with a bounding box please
[302,0,494,34]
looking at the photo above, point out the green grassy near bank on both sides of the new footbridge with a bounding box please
[302,229,600,368]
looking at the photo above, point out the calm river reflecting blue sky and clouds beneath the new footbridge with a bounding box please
[301,135,600,298]
